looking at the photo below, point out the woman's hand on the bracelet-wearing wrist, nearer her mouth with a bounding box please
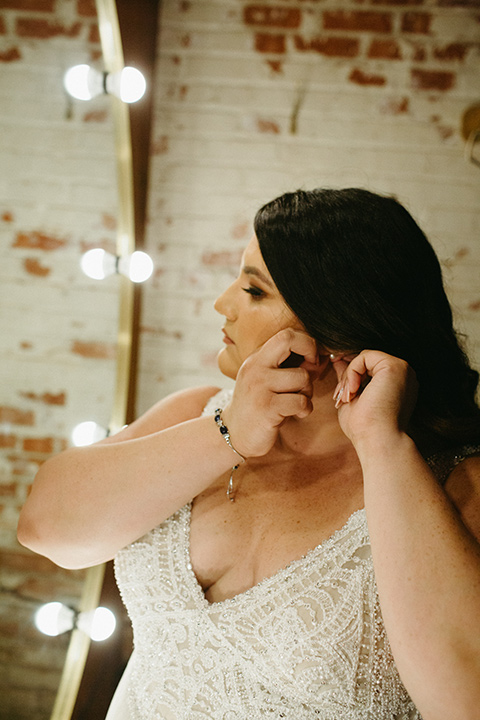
[224,328,329,457]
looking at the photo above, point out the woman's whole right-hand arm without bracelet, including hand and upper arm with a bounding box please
[339,352,480,720]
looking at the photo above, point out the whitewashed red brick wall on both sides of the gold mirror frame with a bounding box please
[0,0,480,720]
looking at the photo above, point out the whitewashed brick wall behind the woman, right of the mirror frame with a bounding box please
[139,0,480,410]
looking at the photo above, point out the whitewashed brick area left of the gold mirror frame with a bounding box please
[0,0,118,720]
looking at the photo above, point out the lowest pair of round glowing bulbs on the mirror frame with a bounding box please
[35,602,117,641]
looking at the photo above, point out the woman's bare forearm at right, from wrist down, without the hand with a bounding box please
[356,433,480,720]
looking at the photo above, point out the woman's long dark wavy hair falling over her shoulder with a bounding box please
[254,188,480,447]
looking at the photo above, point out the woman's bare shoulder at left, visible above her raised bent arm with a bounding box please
[102,385,220,443]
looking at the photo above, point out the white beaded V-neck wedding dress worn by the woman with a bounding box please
[107,394,478,720]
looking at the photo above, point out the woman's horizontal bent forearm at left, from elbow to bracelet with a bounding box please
[18,416,242,568]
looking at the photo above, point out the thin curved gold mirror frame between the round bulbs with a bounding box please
[50,0,135,720]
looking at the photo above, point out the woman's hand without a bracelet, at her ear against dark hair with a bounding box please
[332,350,418,445]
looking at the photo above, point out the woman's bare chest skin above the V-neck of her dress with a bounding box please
[190,464,363,602]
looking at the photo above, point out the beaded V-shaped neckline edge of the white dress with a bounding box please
[182,502,368,610]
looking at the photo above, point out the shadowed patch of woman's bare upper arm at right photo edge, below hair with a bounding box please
[445,455,480,541]
